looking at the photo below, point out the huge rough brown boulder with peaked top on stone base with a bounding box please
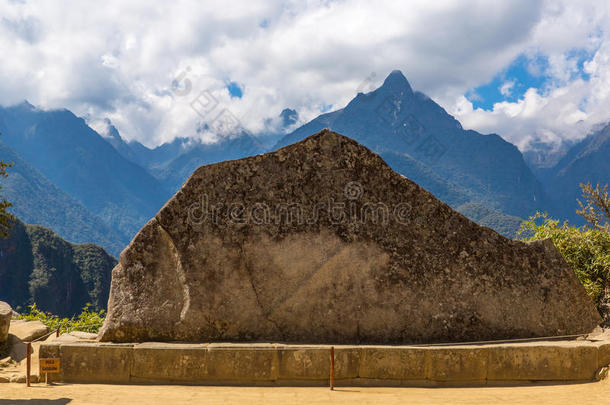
[99,130,600,344]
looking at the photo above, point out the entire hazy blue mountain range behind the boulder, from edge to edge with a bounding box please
[0,71,610,248]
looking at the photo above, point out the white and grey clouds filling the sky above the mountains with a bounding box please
[0,0,610,150]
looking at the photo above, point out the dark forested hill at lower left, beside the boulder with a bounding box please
[0,219,117,316]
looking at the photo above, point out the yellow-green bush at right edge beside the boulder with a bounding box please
[519,213,610,307]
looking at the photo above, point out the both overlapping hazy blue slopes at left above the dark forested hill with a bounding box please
[0,103,171,255]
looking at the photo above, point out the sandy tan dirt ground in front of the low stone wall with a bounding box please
[0,379,610,405]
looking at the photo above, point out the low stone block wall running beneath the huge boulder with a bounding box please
[40,339,610,386]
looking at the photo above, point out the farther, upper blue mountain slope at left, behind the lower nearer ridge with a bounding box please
[0,103,170,245]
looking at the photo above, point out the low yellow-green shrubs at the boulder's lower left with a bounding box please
[19,303,105,333]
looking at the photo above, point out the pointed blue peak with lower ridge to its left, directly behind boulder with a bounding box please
[92,71,551,237]
